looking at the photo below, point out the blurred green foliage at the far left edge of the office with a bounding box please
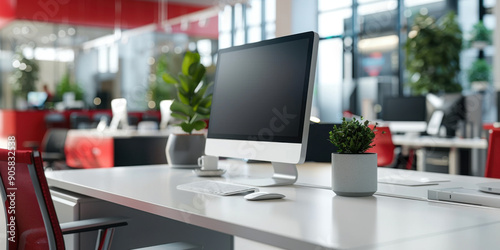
[10,53,38,99]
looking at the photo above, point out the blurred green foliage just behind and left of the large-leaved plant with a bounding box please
[148,54,176,108]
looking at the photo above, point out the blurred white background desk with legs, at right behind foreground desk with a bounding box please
[392,135,488,174]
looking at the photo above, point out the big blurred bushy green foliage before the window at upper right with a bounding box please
[404,12,462,95]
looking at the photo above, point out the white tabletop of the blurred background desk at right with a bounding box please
[392,135,488,149]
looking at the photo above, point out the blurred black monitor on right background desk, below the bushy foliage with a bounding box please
[382,96,427,122]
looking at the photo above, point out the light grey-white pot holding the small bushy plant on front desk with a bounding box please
[332,153,377,197]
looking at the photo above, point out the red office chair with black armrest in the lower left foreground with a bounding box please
[0,149,127,250]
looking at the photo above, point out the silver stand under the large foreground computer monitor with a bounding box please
[235,162,298,187]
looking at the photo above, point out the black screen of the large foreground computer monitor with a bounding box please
[208,32,313,142]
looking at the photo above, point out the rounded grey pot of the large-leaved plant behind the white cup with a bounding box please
[165,134,206,167]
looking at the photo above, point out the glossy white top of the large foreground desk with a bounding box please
[46,162,500,249]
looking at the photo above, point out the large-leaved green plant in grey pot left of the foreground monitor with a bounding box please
[162,51,212,167]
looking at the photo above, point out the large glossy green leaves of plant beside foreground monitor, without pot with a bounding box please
[162,51,212,134]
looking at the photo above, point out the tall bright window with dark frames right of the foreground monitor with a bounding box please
[315,0,478,122]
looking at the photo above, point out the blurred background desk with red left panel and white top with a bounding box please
[64,129,168,168]
